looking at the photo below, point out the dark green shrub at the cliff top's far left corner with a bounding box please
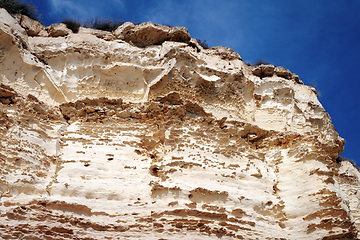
[0,0,40,21]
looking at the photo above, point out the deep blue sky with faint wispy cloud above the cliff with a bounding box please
[31,0,360,166]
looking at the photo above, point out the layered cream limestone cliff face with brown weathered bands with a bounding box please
[0,9,360,239]
